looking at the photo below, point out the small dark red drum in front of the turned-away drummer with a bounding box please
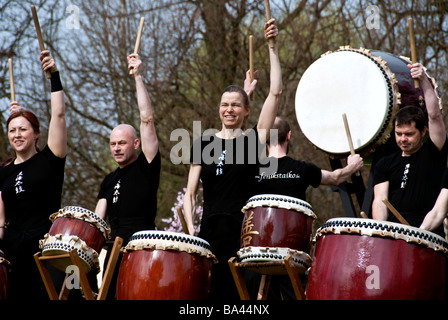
[237,194,316,268]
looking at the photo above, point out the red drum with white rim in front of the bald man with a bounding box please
[117,231,216,300]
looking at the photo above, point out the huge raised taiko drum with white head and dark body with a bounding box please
[295,46,442,156]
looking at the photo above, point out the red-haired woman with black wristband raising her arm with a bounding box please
[0,50,67,300]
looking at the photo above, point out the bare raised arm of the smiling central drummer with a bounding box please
[257,19,283,143]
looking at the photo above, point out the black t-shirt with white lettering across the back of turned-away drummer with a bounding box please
[255,156,322,201]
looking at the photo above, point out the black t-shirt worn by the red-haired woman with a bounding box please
[0,146,65,231]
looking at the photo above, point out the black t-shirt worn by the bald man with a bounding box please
[97,152,161,230]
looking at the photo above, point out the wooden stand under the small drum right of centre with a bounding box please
[228,255,305,300]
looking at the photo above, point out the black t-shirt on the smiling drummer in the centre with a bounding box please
[191,129,259,218]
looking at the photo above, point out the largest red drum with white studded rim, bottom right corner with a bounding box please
[307,218,448,300]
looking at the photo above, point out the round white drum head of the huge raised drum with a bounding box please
[295,50,399,155]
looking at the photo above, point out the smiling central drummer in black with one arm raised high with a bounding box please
[184,19,282,299]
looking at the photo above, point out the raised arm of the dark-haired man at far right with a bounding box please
[408,63,446,150]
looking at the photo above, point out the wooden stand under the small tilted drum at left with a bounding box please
[34,237,123,300]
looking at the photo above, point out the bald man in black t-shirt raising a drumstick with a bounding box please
[95,54,160,245]
